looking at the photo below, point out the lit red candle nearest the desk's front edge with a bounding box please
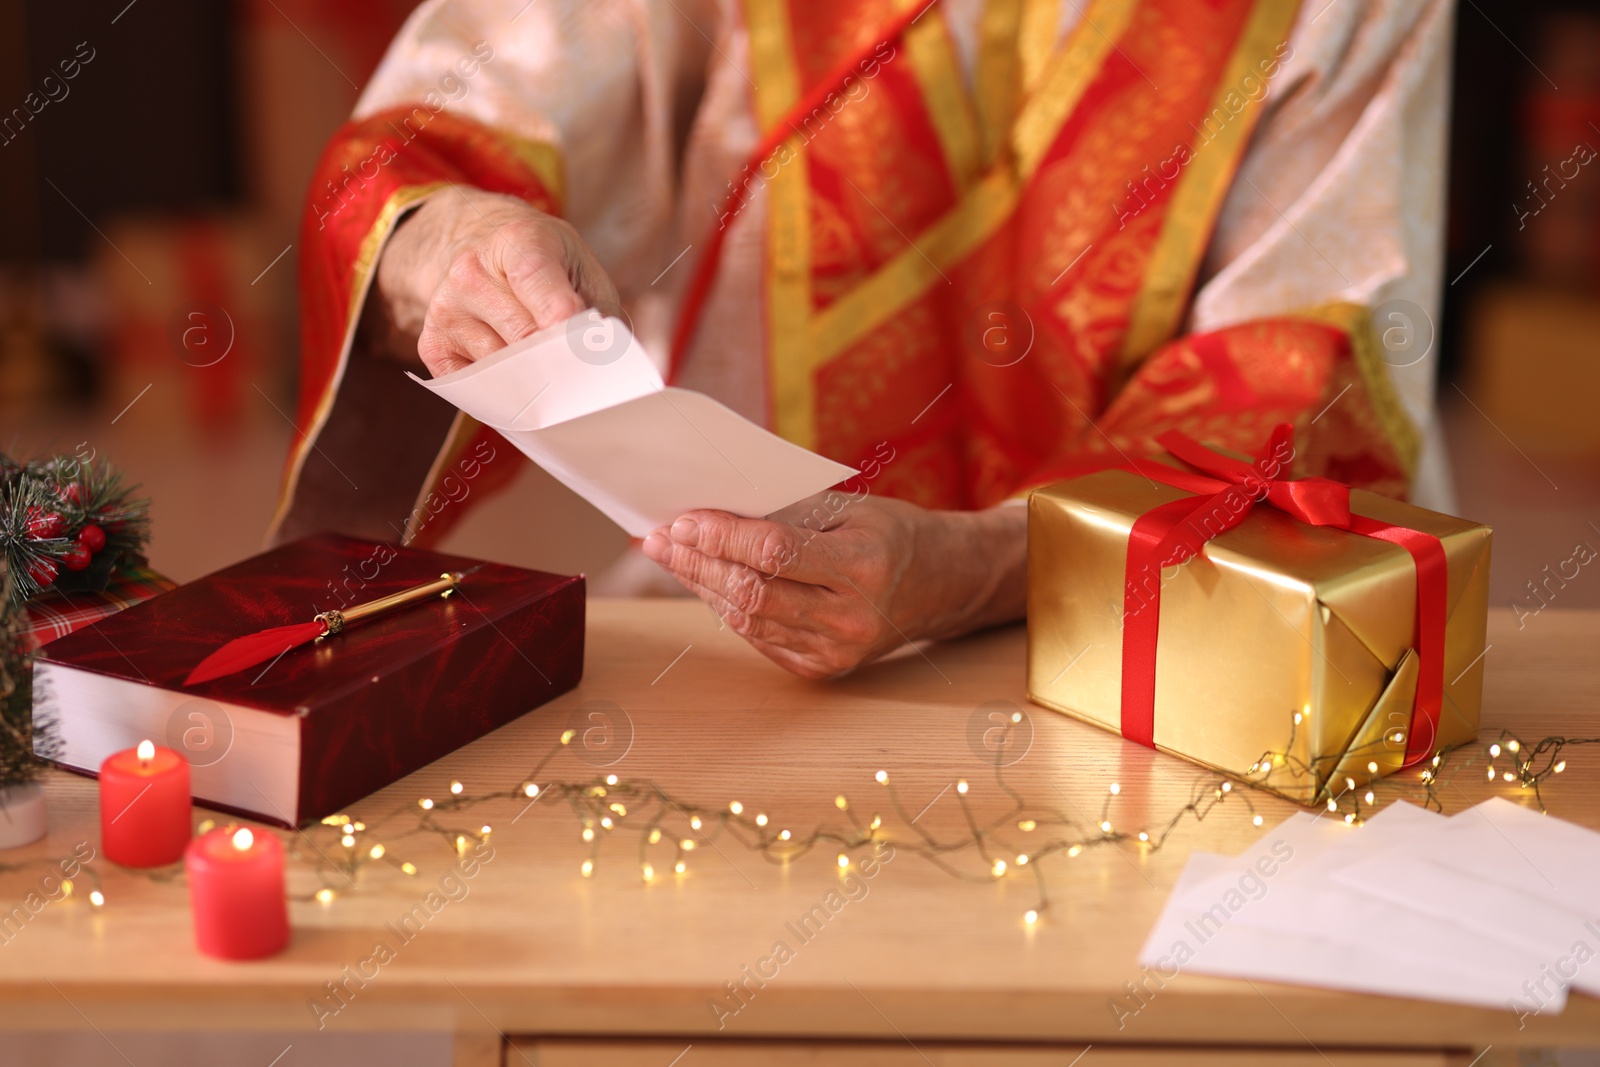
[186,827,290,960]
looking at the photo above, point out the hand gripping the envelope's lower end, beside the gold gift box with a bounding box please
[643,491,1027,678]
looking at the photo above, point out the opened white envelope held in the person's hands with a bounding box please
[411,310,859,537]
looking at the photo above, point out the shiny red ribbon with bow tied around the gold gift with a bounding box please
[1122,422,1450,766]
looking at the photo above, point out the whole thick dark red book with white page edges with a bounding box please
[34,534,584,827]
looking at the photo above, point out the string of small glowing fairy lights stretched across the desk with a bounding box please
[12,726,1600,926]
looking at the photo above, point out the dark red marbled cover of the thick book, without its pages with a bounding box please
[38,534,584,825]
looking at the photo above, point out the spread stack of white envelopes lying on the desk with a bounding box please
[1128,798,1600,1016]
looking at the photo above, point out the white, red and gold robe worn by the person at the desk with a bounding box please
[277,0,1450,563]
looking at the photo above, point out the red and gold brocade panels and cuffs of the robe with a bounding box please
[280,0,1418,537]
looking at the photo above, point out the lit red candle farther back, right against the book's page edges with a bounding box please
[101,741,194,867]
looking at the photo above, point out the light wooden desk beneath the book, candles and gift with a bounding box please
[0,601,1600,1067]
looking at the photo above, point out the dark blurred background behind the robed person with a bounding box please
[0,0,1600,608]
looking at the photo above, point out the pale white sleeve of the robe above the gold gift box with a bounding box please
[1189,0,1454,510]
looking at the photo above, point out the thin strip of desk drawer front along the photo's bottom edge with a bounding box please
[506,1038,1466,1067]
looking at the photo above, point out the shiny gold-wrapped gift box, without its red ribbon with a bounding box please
[1027,470,1493,803]
